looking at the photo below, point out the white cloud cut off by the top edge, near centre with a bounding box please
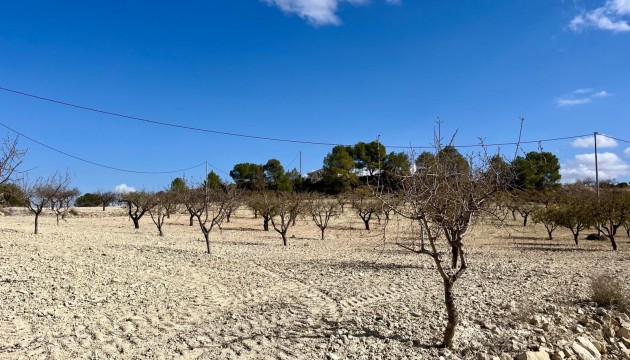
[261,0,400,25]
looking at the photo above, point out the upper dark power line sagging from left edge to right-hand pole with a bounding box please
[0,86,591,149]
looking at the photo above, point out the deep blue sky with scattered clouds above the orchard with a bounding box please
[0,0,630,192]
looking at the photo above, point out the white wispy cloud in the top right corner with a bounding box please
[569,0,630,32]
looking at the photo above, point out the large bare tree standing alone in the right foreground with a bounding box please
[385,136,510,348]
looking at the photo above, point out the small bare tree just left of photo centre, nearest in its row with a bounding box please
[264,192,303,246]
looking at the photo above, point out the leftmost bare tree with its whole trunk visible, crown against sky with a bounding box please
[16,173,70,234]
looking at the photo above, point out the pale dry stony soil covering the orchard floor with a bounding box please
[0,208,630,359]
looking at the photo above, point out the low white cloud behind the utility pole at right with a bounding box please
[560,152,630,183]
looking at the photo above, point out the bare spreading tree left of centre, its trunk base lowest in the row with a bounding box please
[185,187,240,254]
